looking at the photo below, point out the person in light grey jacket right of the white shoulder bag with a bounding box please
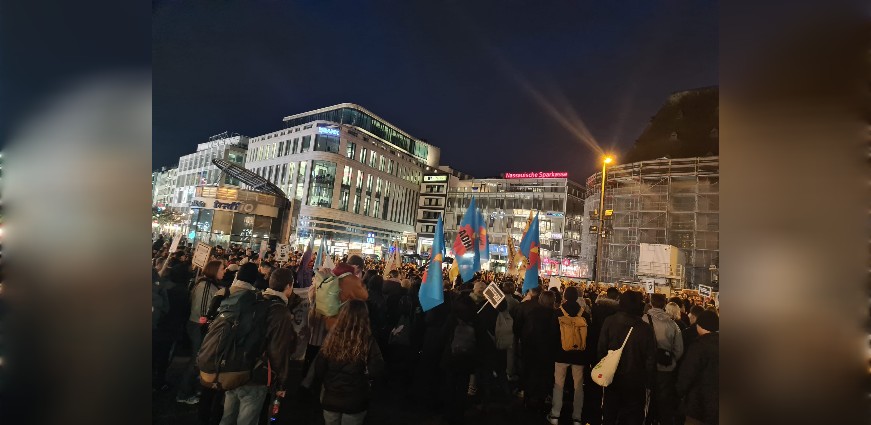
[641,294,684,425]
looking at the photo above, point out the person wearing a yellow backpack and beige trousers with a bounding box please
[547,286,592,424]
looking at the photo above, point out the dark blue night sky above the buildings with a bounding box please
[152,0,719,181]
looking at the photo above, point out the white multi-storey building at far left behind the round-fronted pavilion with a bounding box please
[170,132,248,212]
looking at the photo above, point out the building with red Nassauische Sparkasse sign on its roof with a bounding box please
[444,172,587,277]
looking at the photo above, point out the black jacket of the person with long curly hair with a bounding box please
[314,338,384,414]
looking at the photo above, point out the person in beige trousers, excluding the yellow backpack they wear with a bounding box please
[547,286,593,424]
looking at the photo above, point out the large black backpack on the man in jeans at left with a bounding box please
[197,290,268,391]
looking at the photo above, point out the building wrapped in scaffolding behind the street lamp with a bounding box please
[581,156,720,288]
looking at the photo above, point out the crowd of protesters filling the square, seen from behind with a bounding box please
[152,238,719,425]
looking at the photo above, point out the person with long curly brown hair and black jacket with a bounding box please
[312,299,384,425]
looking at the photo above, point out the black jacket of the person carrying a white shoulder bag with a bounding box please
[596,312,656,389]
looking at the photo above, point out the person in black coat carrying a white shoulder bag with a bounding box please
[597,290,656,425]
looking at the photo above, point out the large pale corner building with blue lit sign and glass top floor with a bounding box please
[245,103,440,256]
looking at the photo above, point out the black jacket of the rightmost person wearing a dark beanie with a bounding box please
[677,333,720,425]
